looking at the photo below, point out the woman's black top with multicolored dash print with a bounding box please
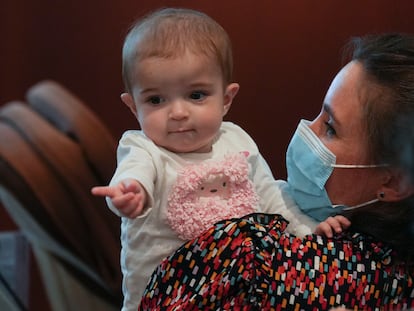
[138,214,414,311]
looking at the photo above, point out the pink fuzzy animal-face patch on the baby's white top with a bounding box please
[167,152,259,240]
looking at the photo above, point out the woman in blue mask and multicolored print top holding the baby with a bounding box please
[139,34,414,310]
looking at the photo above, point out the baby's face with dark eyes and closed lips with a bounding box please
[128,52,234,153]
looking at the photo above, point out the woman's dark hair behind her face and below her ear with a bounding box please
[345,33,414,260]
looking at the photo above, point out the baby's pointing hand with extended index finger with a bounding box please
[91,179,147,218]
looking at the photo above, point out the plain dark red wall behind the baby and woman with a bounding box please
[0,0,414,310]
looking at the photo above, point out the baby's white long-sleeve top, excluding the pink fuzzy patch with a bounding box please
[107,122,316,311]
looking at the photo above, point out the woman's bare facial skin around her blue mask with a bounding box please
[310,62,383,206]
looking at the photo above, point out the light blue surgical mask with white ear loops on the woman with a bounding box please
[286,120,383,221]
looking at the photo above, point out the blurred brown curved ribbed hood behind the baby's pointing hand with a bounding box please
[0,81,121,305]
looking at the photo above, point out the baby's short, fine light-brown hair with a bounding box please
[122,8,233,93]
